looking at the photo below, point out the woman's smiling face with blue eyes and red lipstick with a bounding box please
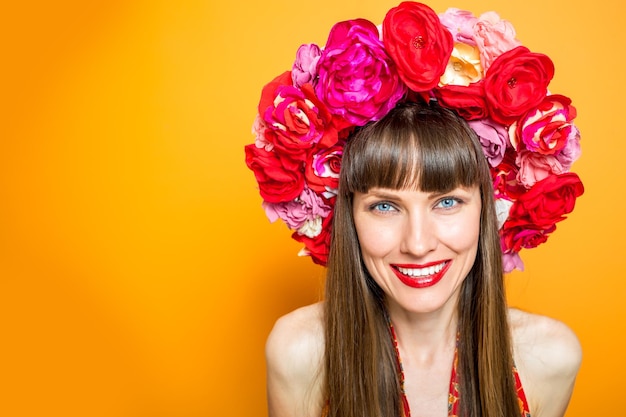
[353,186,481,313]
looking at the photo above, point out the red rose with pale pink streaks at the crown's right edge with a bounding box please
[511,94,576,155]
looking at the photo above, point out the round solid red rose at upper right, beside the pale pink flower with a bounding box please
[485,46,554,125]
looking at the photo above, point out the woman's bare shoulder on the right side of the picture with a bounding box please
[509,309,582,417]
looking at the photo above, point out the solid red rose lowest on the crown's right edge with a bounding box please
[507,172,584,229]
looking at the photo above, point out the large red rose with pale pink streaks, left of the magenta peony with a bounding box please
[259,71,337,154]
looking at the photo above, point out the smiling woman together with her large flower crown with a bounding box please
[246,1,583,417]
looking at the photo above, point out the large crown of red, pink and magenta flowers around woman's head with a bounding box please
[245,1,583,272]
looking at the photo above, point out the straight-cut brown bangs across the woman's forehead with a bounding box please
[342,103,485,193]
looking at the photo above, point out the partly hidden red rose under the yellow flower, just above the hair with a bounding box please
[434,82,489,120]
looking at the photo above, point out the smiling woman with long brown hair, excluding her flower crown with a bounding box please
[266,103,581,417]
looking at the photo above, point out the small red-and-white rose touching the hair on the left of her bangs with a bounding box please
[305,141,344,199]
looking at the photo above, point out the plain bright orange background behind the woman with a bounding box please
[0,0,626,417]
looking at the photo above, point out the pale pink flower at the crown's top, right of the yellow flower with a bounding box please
[474,12,521,71]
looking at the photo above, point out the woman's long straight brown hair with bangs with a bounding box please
[324,103,520,417]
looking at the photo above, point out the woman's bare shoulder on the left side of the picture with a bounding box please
[265,303,324,417]
